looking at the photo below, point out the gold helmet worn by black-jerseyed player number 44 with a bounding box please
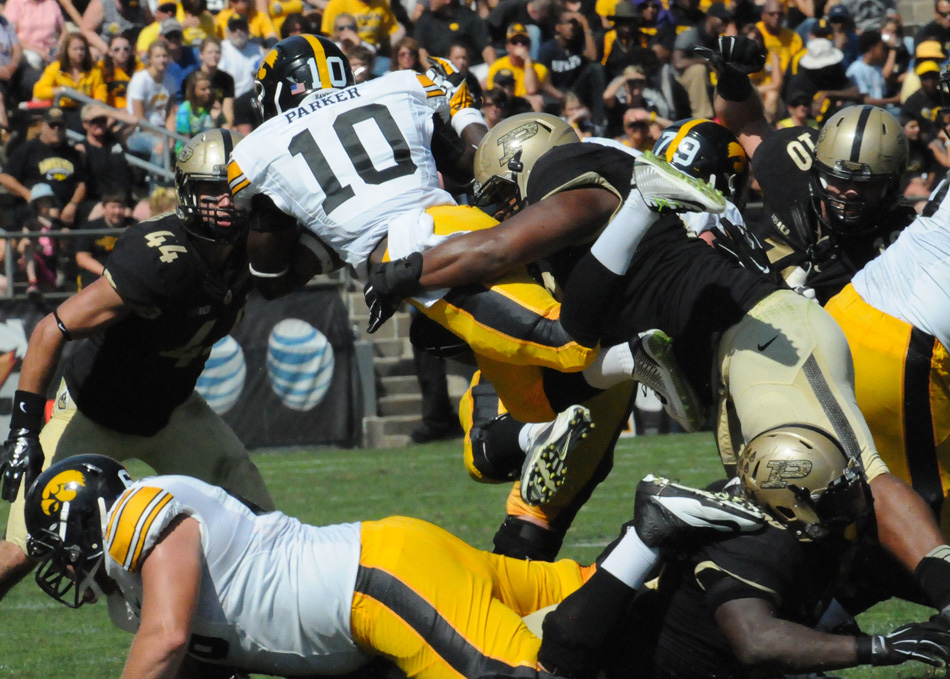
[175,130,246,243]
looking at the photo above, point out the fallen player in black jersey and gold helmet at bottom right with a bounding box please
[538,425,950,679]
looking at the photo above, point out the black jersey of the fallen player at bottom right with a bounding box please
[653,526,842,679]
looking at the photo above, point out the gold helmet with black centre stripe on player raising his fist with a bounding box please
[812,106,908,236]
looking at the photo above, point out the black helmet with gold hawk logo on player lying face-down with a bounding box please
[24,455,132,608]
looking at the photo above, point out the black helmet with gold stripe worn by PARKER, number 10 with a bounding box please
[252,33,355,121]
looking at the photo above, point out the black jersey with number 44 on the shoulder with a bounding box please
[65,213,250,436]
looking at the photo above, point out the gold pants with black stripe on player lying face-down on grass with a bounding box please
[351,516,595,679]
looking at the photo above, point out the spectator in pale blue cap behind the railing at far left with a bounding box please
[17,183,63,301]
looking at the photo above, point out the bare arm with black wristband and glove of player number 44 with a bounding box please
[0,278,131,502]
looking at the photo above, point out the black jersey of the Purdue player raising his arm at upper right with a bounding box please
[752,127,916,304]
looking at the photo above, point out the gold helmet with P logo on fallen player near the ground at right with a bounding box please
[738,424,872,542]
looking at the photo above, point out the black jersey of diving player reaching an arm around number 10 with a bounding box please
[528,144,778,401]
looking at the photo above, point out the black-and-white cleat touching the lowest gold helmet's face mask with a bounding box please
[633,474,766,549]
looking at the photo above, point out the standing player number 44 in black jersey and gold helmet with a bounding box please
[0,130,273,595]
